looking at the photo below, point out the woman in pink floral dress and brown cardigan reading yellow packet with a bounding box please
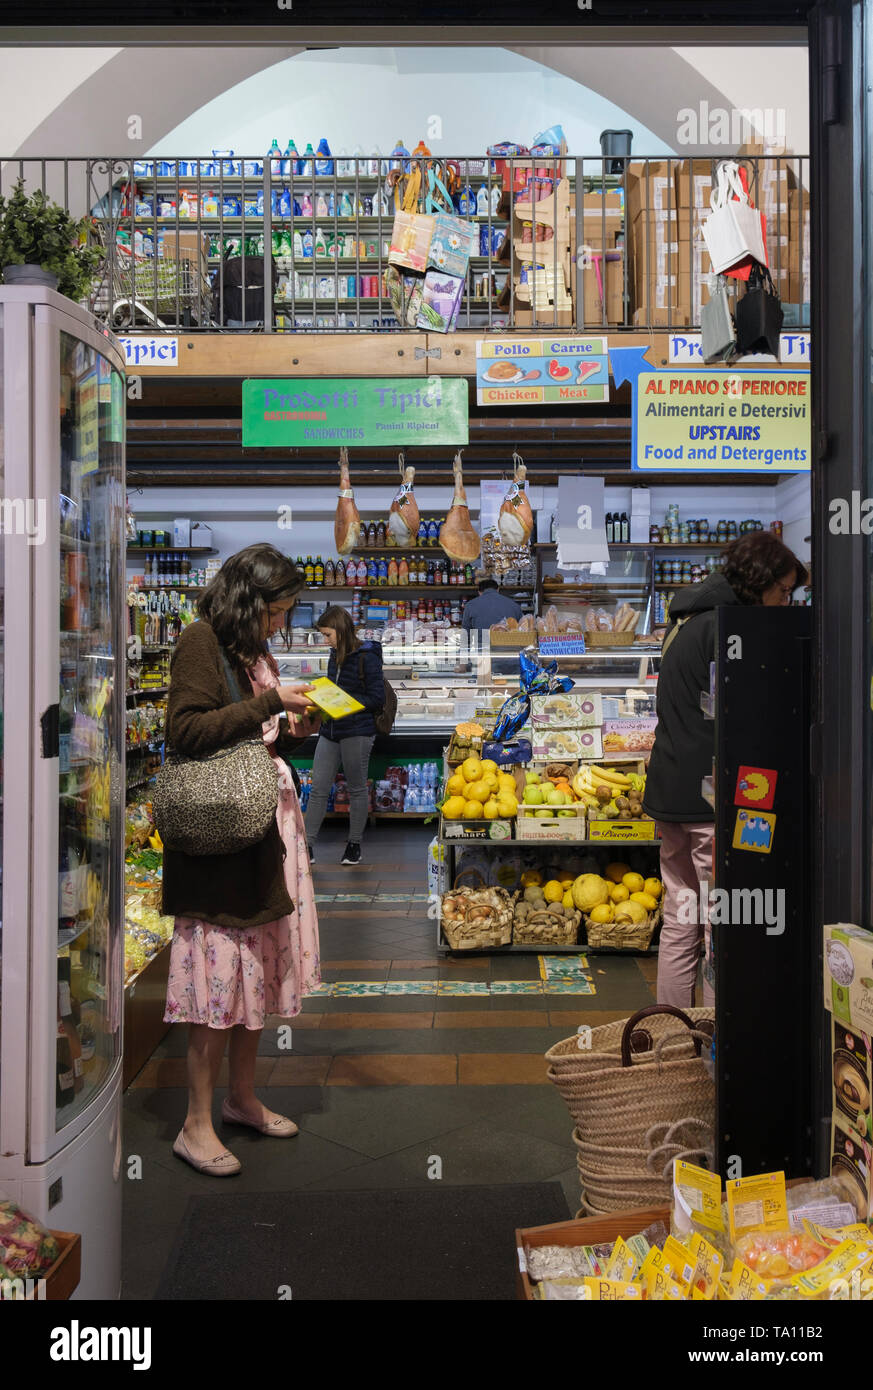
[163,545,320,1177]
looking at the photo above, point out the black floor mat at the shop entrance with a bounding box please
[156,1183,570,1302]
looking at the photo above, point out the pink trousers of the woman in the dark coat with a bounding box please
[658,820,715,1009]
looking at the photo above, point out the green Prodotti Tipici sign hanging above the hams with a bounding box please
[242,377,470,449]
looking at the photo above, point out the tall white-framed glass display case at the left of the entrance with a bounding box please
[0,288,125,1298]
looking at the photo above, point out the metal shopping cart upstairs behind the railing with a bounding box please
[90,218,211,331]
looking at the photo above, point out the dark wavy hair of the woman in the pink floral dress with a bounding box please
[197,545,306,669]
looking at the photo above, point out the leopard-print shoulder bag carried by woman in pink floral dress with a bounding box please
[152,651,279,855]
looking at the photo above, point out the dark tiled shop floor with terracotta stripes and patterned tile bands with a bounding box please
[124,824,656,1300]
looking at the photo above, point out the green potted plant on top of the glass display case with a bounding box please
[0,179,101,303]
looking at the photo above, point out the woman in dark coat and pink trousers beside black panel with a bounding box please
[644,531,808,1009]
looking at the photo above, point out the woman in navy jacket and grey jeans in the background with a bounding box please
[306,606,385,865]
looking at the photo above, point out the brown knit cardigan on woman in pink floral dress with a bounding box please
[163,620,302,927]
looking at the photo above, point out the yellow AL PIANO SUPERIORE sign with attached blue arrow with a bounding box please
[612,349,812,473]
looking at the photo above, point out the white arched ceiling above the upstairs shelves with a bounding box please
[0,44,808,157]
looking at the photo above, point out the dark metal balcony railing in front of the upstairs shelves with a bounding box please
[0,153,809,334]
